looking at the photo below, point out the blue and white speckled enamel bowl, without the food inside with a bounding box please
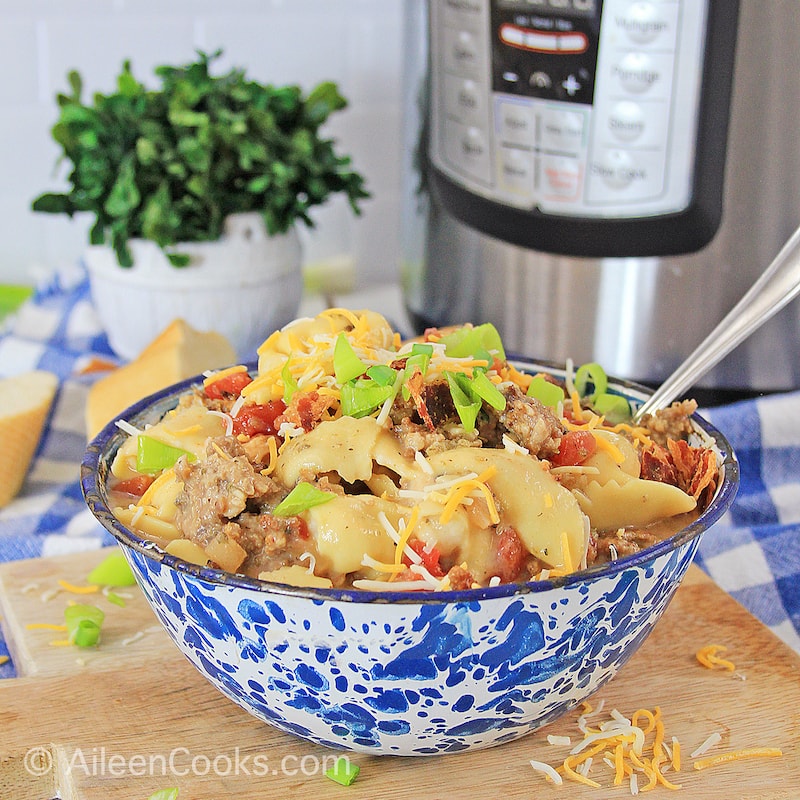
[81,361,739,755]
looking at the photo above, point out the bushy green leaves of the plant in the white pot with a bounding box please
[32,51,369,267]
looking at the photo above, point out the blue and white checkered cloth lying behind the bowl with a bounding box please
[0,267,800,676]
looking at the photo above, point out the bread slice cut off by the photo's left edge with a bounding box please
[0,370,58,508]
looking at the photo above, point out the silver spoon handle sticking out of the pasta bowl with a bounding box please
[633,220,800,421]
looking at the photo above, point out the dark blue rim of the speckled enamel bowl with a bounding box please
[81,355,739,605]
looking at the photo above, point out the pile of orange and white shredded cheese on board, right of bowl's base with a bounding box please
[530,701,783,795]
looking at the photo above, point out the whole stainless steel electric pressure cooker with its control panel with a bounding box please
[401,0,800,399]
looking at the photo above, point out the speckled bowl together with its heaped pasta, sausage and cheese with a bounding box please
[81,309,738,755]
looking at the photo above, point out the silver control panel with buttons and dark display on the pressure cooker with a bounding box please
[429,0,710,231]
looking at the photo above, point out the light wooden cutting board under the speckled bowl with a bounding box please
[0,552,800,800]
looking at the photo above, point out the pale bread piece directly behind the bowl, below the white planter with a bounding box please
[86,319,236,439]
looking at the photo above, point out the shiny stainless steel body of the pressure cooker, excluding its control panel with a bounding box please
[401,0,800,391]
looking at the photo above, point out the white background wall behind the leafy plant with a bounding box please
[0,0,403,285]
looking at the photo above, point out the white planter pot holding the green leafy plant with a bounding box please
[85,213,303,361]
